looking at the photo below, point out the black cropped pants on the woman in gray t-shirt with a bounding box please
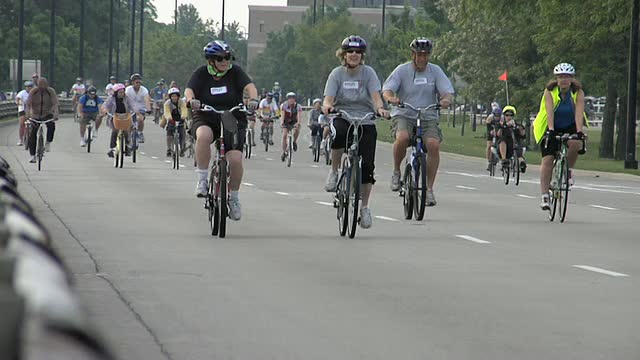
[331,118,378,184]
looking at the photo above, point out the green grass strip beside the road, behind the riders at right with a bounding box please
[378,115,640,176]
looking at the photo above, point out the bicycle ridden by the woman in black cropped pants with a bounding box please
[332,110,375,239]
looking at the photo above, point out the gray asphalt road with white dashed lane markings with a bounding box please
[0,118,640,360]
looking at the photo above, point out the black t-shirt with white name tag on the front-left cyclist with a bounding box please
[187,65,252,118]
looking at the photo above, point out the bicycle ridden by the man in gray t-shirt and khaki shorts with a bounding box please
[398,103,440,221]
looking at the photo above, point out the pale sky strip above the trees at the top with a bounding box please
[152,0,287,29]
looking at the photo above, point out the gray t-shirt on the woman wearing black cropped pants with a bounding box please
[324,65,380,125]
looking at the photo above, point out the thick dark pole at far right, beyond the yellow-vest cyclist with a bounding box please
[624,0,640,169]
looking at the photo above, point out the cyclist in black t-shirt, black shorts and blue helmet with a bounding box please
[185,40,259,220]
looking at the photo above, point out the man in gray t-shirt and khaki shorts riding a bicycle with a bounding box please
[382,38,454,206]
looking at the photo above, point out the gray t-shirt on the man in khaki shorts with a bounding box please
[382,62,454,120]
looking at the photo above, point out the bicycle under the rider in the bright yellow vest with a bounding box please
[545,134,587,222]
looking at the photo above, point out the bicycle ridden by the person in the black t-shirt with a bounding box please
[199,104,250,238]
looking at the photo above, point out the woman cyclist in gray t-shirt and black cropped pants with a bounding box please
[322,35,388,229]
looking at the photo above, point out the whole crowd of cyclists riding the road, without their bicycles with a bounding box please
[16,35,586,229]
